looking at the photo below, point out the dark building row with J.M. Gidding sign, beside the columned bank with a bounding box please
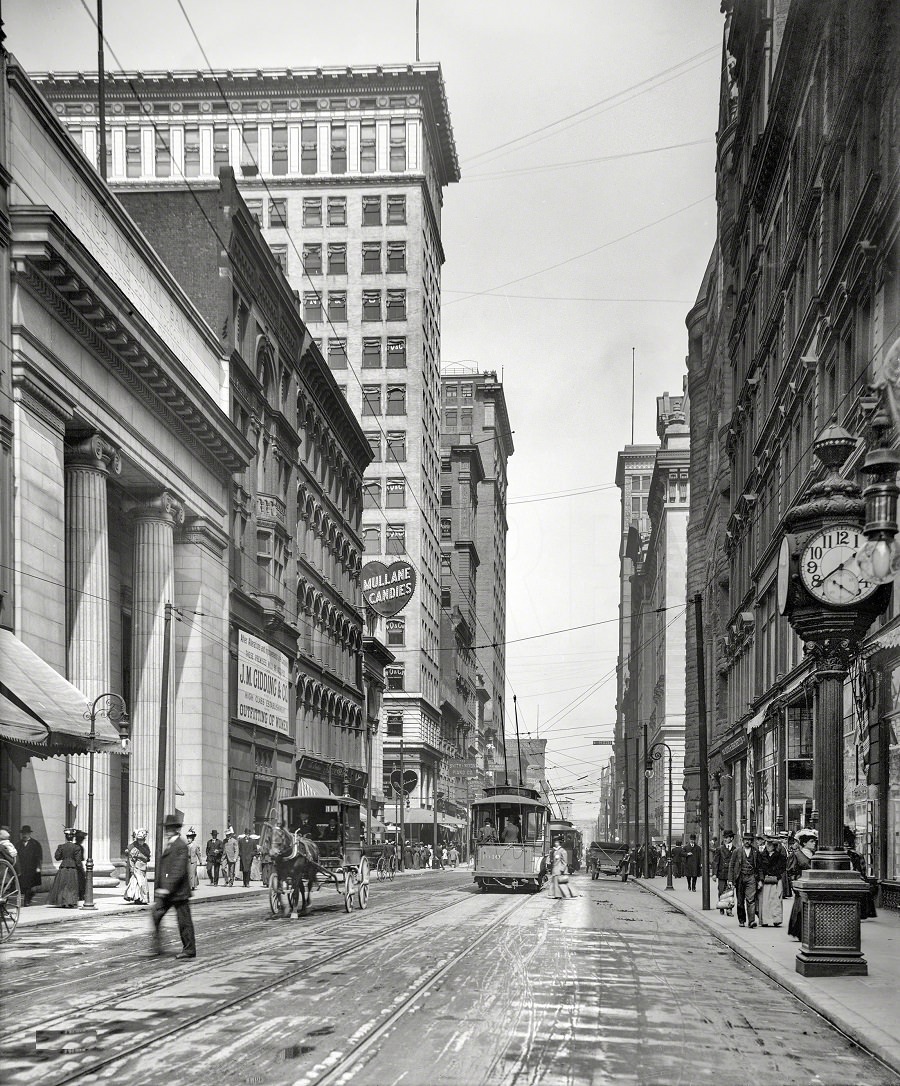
[121,167,371,829]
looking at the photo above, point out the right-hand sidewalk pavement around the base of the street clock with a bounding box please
[630,877,900,1073]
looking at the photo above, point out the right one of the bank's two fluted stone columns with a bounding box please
[128,491,185,847]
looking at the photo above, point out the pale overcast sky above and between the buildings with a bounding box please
[2,0,723,820]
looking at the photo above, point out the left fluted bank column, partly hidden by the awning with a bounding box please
[65,433,122,886]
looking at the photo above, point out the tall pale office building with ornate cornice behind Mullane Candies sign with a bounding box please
[39,64,459,807]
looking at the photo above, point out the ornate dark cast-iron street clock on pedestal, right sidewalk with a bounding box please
[778,425,890,976]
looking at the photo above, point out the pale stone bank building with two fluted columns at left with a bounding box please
[0,55,252,874]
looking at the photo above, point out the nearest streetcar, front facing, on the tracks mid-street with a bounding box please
[469,784,550,893]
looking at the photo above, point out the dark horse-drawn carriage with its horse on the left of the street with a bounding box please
[259,795,369,917]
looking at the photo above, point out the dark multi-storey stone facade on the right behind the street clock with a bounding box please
[688,0,900,900]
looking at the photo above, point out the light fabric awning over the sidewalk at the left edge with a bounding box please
[0,630,122,758]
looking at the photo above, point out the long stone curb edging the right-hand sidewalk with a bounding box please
[631,876,900,1074]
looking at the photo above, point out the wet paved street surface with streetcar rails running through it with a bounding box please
[0,870,900,1086]
